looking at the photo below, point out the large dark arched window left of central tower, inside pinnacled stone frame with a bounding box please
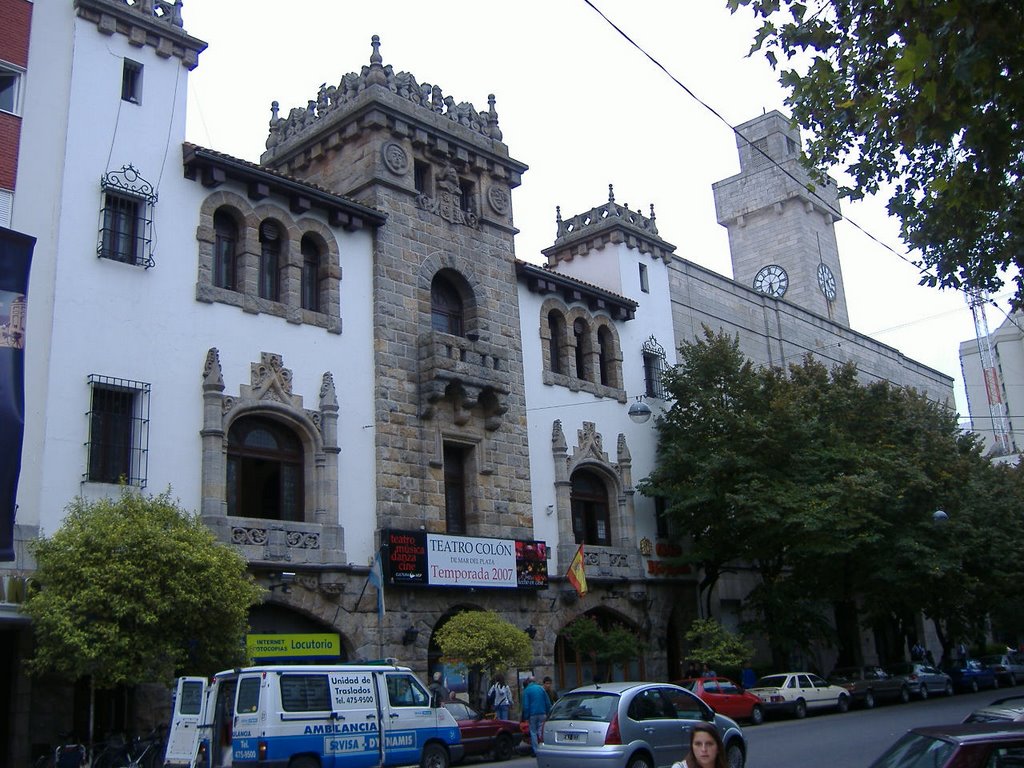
[227,416,303,521]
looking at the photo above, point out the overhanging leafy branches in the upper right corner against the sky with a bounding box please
[728,0,1024,305]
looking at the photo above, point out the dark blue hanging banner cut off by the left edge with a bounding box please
[0,227,36,561]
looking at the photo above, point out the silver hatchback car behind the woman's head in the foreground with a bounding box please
[537,683,746,768]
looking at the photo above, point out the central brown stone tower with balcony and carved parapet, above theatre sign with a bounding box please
[261,36,534,538]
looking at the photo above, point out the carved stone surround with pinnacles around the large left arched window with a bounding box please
[201,349,347,563]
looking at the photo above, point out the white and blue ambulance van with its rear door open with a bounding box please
[164,659,464,768]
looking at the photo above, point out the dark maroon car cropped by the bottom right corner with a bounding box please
[869,723,1024,768]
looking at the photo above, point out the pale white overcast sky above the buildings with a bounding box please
[176,0,1007,417]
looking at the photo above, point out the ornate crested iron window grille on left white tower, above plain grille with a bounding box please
[96,164,157,269]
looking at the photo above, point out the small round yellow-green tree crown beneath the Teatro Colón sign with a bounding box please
[434,610,532,672]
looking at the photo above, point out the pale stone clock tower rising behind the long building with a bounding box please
[713,112,850,326]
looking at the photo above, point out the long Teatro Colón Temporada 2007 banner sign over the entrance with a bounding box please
[383,530,548,589]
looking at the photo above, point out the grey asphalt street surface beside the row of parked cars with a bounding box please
[477,685,1007,768]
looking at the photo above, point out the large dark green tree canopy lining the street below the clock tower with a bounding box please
[639,329,1024,664]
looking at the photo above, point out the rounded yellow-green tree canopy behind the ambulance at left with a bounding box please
[25,489,263,687]
